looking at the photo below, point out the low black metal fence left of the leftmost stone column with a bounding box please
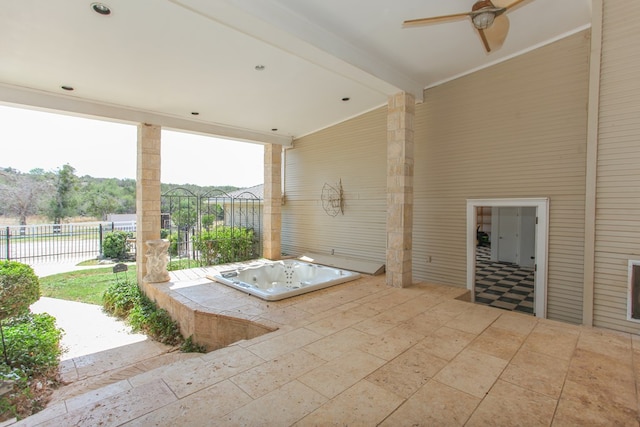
[0,221,136,264]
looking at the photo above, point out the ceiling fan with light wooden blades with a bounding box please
[402,0,527,53]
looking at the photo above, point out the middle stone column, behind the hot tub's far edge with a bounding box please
[262,144,282,260]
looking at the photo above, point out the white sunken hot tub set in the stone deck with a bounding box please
[212,260,360,301]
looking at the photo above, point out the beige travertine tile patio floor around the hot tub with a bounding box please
[12,270,640,426]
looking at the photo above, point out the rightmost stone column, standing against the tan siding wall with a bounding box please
[386,92,415,288]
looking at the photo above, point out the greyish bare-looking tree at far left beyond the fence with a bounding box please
[0,171,50,225]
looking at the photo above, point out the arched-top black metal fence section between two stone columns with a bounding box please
[162,188,263,266]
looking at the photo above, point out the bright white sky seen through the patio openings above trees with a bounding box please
[0,105,264,188]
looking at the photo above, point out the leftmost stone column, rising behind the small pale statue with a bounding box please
[136,123,161,285]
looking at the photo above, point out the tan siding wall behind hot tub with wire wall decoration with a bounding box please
[282,105,387,263]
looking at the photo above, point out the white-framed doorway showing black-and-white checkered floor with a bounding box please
[467,198,549,317]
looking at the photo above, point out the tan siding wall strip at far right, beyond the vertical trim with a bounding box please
[594,0,640,333]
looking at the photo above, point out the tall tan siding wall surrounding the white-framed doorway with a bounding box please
[413,32,589,323]
